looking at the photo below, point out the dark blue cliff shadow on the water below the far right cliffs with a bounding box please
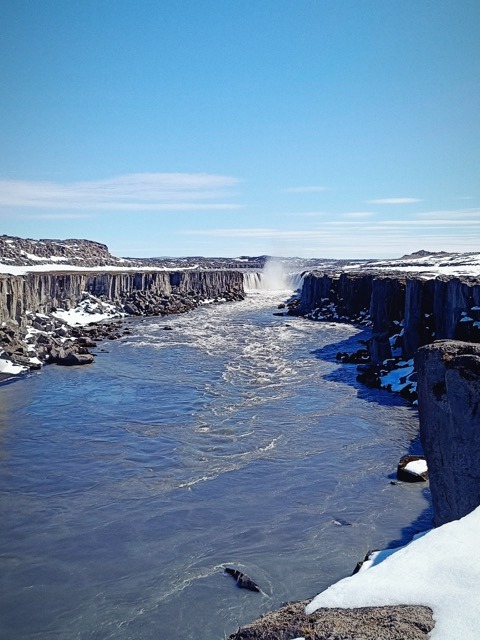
[311,330,416,411]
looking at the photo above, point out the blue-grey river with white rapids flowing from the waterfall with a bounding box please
[0,292,430,640]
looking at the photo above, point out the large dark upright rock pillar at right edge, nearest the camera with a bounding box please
[415,340,480,526]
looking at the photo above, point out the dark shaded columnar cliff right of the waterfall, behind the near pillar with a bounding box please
[292,271,480,364]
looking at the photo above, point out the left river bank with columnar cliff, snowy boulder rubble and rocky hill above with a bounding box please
[0,236,244,380]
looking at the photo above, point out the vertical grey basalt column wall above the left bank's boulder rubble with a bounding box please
[0,270,244,325]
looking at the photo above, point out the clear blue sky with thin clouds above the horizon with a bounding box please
[0,0,480,258]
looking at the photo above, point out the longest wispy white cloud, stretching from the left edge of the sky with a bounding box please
[0,173,239,211]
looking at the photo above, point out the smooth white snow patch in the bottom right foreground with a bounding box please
[305,507,480,640]
